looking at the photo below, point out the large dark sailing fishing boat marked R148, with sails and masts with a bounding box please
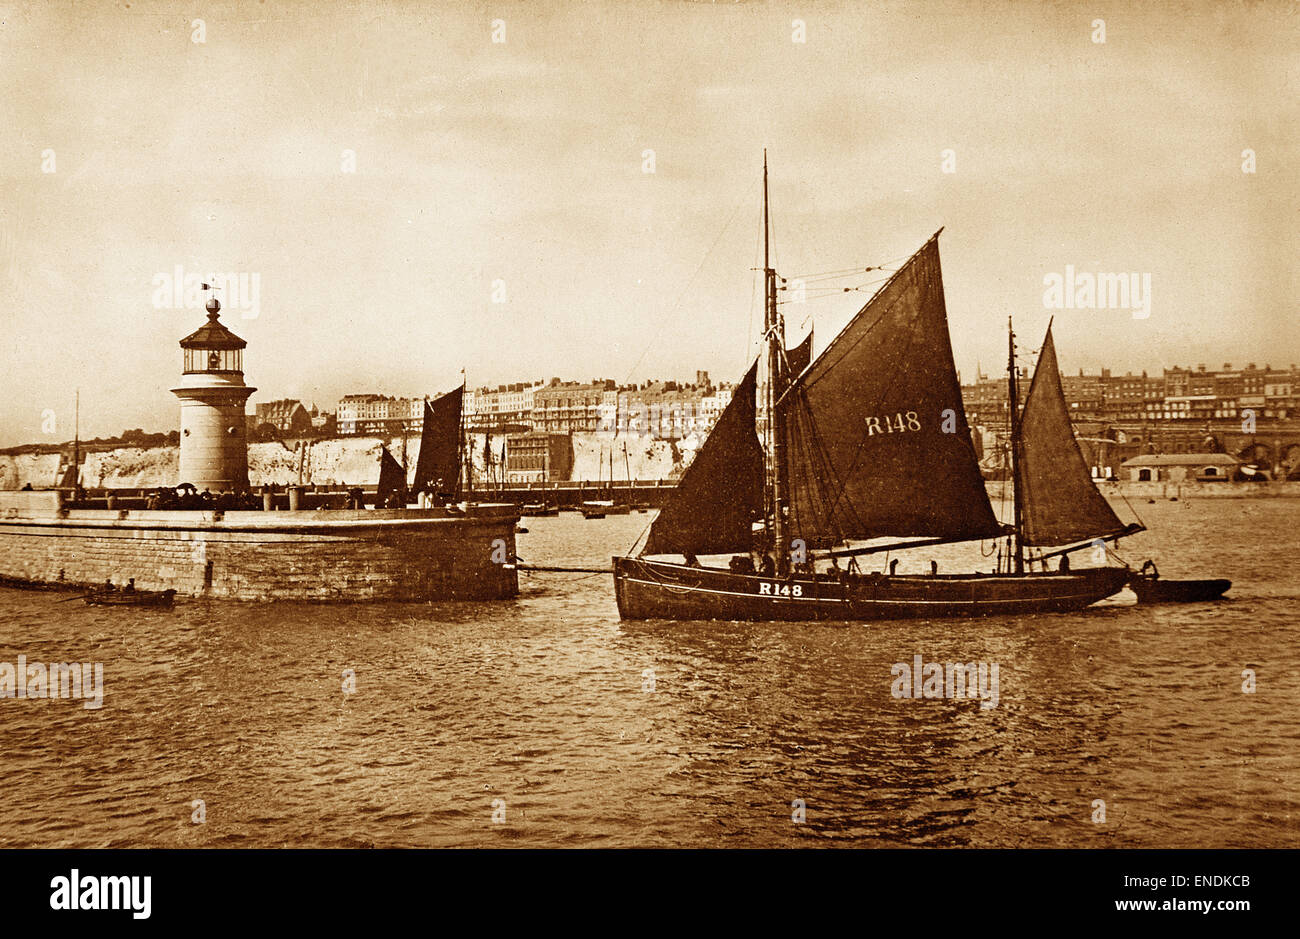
[614,157,1141,620]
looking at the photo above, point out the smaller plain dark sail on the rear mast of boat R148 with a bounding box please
[1015,324,1126,545]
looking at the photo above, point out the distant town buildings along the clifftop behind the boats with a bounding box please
[213,363,1300,483]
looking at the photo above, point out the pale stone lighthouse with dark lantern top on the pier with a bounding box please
[172,297,257,493]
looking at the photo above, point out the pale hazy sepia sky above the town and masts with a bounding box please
[0,0,1300,445]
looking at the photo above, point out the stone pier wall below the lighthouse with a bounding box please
[0,493,519,601]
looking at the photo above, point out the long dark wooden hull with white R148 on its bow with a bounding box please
[614,558,1130,622]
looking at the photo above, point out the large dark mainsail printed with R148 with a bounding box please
[781,233,1001,546]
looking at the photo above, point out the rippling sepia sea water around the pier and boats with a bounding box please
[0,499,1300,847]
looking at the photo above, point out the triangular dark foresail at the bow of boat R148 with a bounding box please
[641,363,763,554]
